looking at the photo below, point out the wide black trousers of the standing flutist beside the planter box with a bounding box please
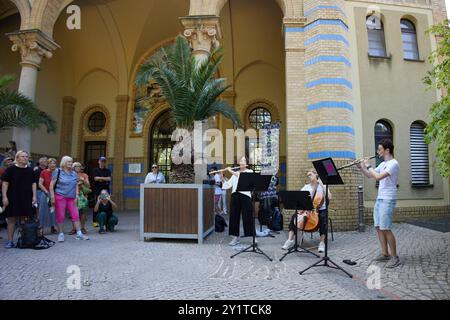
[229,192,255,237]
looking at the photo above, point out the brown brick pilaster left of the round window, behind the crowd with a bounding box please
[59,97,76,156]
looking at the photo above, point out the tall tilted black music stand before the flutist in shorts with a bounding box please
[299,158,353,278]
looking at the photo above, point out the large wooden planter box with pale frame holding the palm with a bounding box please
[140,184,214,244]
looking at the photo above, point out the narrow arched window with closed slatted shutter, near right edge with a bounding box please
[409,121,430,186]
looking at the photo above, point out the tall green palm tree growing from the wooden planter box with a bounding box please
[136,36,241,183]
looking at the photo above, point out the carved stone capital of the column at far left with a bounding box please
[6,29,59,69]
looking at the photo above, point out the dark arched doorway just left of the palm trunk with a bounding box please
[148,111,176,180]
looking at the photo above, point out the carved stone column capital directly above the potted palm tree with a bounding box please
[180,16,222,56]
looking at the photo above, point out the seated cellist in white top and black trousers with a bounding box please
[282,169,331,252]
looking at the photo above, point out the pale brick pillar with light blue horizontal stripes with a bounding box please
[304,0,362,230]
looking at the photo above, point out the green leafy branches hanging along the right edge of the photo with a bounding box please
[424,20,450,178]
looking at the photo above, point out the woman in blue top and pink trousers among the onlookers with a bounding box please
[50,156,89,242]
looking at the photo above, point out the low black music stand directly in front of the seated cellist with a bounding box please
[280,191,320,261]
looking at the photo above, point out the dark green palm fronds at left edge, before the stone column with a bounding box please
[0,75,56,133]
